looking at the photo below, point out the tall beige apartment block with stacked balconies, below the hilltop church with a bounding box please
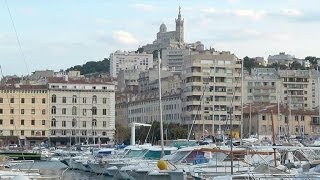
[181,50,242,136]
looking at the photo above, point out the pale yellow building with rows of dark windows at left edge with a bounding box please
[0,85,50,147]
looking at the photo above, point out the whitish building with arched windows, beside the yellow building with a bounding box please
[48,76,115,144]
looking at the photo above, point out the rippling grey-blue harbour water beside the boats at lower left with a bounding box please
[10,161,113,180]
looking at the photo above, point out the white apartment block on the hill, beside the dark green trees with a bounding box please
[110,51,153,77]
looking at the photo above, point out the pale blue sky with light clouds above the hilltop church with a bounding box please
[0,0,320,75]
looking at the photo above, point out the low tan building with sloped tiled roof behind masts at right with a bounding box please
[243,103,320,140]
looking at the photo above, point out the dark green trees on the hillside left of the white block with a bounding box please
[67,58,110,74]
